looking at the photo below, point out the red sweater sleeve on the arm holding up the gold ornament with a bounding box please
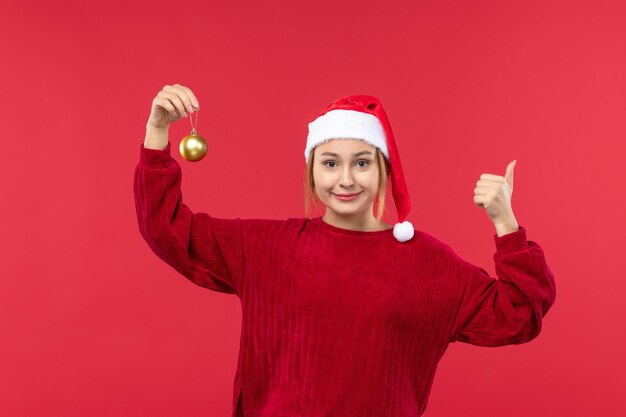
[133,142,242,294]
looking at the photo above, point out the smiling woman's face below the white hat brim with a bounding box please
[313,139,380,215]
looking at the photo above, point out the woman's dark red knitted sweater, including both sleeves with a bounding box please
[134,143,555,417]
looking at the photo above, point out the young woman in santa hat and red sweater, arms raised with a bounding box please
[134,84,556,417]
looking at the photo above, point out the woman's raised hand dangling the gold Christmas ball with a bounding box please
[147,84,200,130]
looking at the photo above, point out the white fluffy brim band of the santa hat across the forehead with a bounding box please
[304,109,389,163]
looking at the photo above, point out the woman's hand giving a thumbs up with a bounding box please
[474,160,518,230]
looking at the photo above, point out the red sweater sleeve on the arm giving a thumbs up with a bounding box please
[451,226,556,346]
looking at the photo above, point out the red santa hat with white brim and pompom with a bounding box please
[304,95,415,242]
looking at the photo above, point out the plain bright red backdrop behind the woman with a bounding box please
[0,0,626,417]
